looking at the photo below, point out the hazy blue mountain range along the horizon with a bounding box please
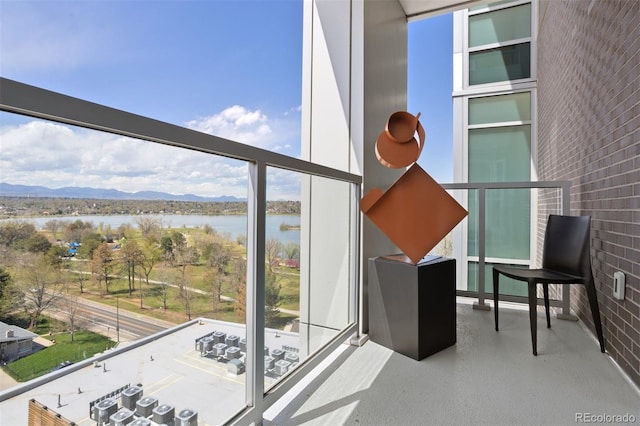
[0,182,247,202]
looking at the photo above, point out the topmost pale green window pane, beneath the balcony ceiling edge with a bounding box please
[469,4,531,47]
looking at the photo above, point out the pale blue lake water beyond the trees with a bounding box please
[7,215,300,244]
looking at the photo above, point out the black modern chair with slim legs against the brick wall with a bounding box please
[493,215,605,355]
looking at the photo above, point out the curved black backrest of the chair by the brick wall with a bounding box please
[542,215,592,281]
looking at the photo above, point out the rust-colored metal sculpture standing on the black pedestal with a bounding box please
[360,111,468,265]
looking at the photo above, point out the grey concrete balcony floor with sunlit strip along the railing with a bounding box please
[264,303,640,425]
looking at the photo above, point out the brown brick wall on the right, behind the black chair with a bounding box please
[538,0,640,385]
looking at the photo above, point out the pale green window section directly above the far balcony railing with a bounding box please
[469,125,531,182]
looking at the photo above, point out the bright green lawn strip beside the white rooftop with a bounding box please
[2,331,115,382]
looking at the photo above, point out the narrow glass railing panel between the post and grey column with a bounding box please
[265,167,355,390]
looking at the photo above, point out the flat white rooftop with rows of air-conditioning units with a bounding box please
[0,319,298,426]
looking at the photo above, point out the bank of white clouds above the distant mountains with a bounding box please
[0,115,300,199]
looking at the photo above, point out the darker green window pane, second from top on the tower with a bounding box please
[469,43,531,85]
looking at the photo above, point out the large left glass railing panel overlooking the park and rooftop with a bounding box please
[0,113,250,424]
